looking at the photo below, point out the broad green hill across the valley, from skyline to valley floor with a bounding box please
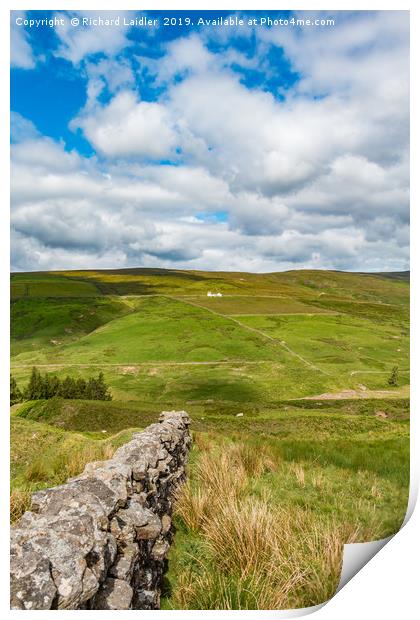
[12,269,409,404]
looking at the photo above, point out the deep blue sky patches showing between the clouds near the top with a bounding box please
[11,11,299,155]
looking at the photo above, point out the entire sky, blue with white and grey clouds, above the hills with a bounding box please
[11,11,409,272]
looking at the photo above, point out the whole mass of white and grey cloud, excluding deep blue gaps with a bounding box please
[12,12,409,271]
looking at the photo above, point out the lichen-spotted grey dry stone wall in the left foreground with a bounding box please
[11,411,191,609]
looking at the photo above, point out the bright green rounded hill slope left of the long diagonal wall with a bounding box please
[10,297,292,364]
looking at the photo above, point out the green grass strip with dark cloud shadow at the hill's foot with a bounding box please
[8,358,352,413]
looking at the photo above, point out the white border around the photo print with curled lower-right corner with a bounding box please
[0,0,420,620]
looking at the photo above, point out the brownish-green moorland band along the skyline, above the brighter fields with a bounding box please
[12,269,409,305]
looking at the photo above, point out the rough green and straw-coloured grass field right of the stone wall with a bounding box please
[163,418,409,609]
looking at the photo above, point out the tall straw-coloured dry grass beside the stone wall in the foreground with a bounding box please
[172,444,359,609]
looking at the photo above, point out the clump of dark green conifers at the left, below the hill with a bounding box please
[10,367,112,404]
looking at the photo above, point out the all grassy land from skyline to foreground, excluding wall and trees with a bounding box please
[11,269,409,609]
